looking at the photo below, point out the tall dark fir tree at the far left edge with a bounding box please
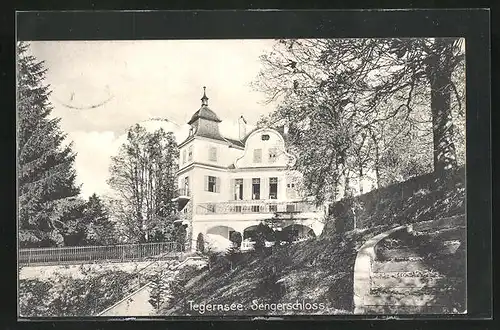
[17,42,83,247]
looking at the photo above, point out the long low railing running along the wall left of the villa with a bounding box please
[19,242,182,265]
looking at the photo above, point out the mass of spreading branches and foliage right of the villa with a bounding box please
[255,38,465,203]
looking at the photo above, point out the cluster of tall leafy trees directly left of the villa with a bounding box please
[108,125,179,242]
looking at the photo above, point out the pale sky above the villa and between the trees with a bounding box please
[31,40,276,197]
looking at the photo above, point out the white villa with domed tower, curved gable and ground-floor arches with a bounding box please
[175,88,326,249]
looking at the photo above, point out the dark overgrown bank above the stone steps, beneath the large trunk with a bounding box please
[322,167,465,235]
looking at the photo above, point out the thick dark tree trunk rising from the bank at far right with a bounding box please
[427,38,457,173]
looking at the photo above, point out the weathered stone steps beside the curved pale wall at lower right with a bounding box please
[357,217,465,314]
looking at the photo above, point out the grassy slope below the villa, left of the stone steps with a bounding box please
[158,227,387,315]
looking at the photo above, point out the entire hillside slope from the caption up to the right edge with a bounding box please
[158,170,465,315]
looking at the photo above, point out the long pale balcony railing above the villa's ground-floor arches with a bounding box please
[196,200,319,214]
